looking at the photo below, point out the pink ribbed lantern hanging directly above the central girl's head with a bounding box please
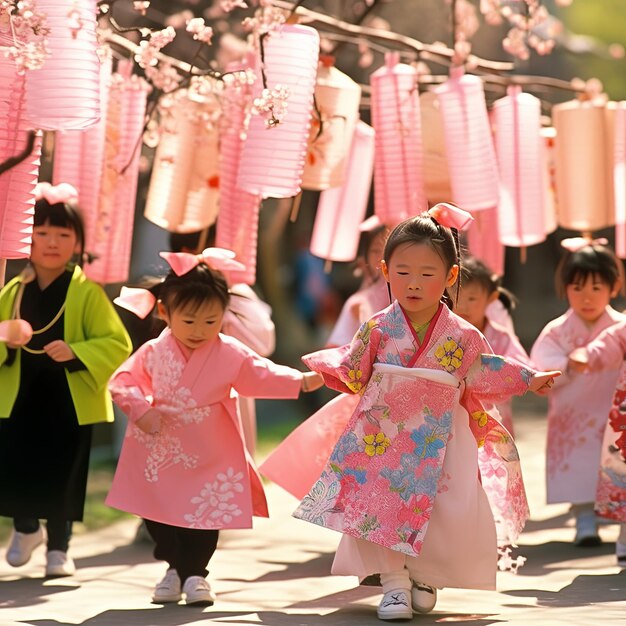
[370,53,428,225]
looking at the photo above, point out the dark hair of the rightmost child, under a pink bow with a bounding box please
[555,242,624,298]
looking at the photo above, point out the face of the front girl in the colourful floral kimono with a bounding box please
[381,243,459,324]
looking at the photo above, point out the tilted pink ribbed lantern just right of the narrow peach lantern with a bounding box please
[435,67,498,213]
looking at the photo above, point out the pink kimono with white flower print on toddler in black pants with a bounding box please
[106,328,302,529]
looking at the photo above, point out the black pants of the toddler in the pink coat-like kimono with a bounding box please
[144,519,219,583]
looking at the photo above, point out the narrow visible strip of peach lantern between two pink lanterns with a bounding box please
[420,91,452,204]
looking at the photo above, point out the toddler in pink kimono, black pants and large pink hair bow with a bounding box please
[106,248,322,605]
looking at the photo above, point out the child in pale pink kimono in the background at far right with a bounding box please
[530,238,626,546]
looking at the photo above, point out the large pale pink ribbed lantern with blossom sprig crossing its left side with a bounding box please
[237,25,319,198]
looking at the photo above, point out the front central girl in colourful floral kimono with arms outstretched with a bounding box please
[294,205,558,620]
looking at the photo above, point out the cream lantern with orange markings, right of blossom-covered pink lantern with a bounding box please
[302,57,361,190]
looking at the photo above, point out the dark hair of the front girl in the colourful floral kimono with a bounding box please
[383,213,461,309]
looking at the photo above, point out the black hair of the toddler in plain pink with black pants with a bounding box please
[153,263,230,312]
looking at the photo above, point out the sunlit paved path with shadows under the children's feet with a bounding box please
[0,402,626,626]
